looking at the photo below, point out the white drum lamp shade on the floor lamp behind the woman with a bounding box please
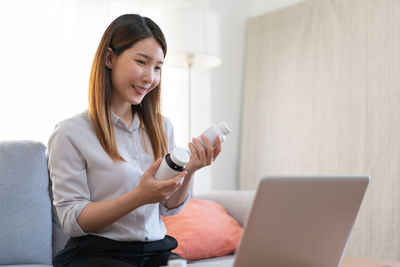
[160,8,221,68]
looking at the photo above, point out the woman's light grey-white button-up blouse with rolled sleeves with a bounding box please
[48,111,189,241]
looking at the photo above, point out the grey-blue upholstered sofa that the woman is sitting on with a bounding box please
[0,141,254,267]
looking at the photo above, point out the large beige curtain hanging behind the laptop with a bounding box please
[239,0,400,260]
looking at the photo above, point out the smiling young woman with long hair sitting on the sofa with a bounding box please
[48,15,221,267]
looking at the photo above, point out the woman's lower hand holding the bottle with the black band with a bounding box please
[137,158,187,204]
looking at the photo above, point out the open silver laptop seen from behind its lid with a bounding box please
[190,176,370,267]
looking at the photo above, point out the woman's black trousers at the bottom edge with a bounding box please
[53,235,180,267]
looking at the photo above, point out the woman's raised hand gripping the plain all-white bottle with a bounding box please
[186,135,221,173]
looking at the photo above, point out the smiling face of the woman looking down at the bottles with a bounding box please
[106,38,164,107]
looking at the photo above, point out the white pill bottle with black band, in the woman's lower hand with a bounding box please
[154,147,190,180]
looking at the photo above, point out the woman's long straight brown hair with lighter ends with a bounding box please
[89,14,167,161]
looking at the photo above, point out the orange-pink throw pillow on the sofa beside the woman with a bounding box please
[162,199,243,260]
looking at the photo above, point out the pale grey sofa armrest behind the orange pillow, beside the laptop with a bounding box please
[194,190,255,226]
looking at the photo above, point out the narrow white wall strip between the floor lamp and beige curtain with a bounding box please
[210,0,302,190]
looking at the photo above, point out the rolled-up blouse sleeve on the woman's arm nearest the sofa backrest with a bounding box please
[48,123,90,237]
